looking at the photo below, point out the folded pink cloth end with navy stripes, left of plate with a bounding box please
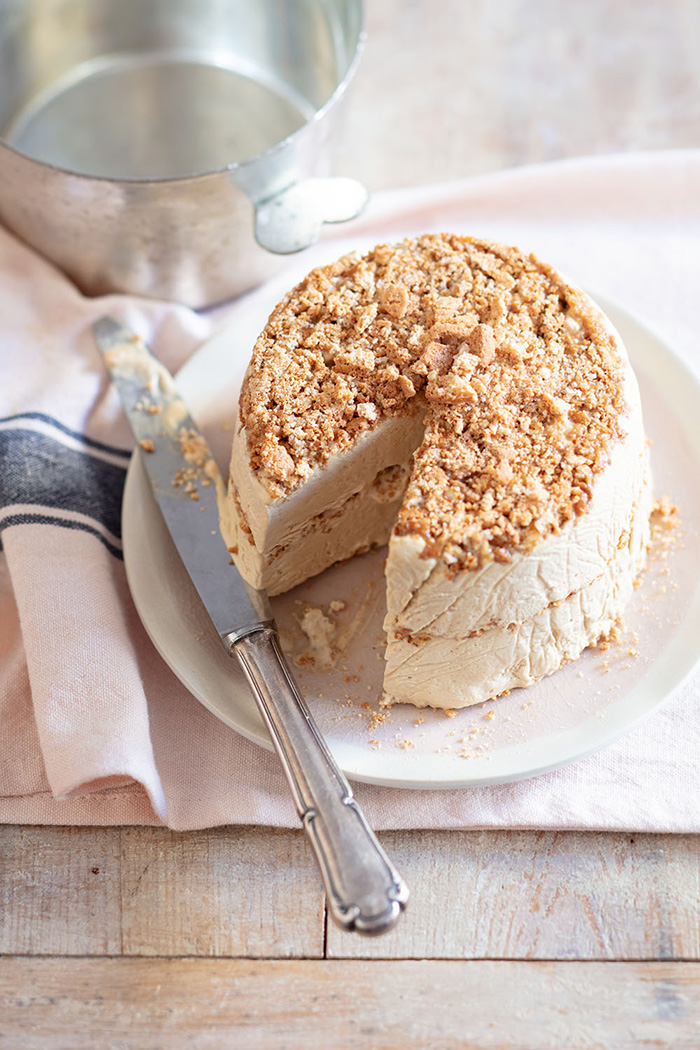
[0,230,211,815]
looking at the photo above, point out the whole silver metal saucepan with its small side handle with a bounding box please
[0,0,366,308]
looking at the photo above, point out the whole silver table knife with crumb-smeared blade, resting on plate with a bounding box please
[93,317,408,935]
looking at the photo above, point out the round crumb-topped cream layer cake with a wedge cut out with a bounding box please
[222,234,651,708]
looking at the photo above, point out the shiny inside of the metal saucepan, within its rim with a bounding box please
[0,0,361,180]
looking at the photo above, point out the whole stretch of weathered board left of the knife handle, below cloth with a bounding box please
[0,826,323,959]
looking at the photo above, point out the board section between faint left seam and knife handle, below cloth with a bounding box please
[122,827,323,959]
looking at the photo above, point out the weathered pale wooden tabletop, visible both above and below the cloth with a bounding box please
[0,0,700,1050]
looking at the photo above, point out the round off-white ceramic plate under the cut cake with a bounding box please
[123,287,700,789]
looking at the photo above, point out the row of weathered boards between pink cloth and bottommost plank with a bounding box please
[5,826,700,960]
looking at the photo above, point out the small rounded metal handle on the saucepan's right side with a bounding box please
[255,176,369,255]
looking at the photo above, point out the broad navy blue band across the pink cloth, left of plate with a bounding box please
[0,420,126,552]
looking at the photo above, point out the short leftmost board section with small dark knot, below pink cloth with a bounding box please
[0,825,121,956]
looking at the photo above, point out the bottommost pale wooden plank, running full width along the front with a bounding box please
[0,959,700,1050]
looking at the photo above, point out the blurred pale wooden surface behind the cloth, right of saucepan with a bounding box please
[336,0,700,190]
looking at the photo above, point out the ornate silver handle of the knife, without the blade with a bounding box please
[226,625,408,935]
